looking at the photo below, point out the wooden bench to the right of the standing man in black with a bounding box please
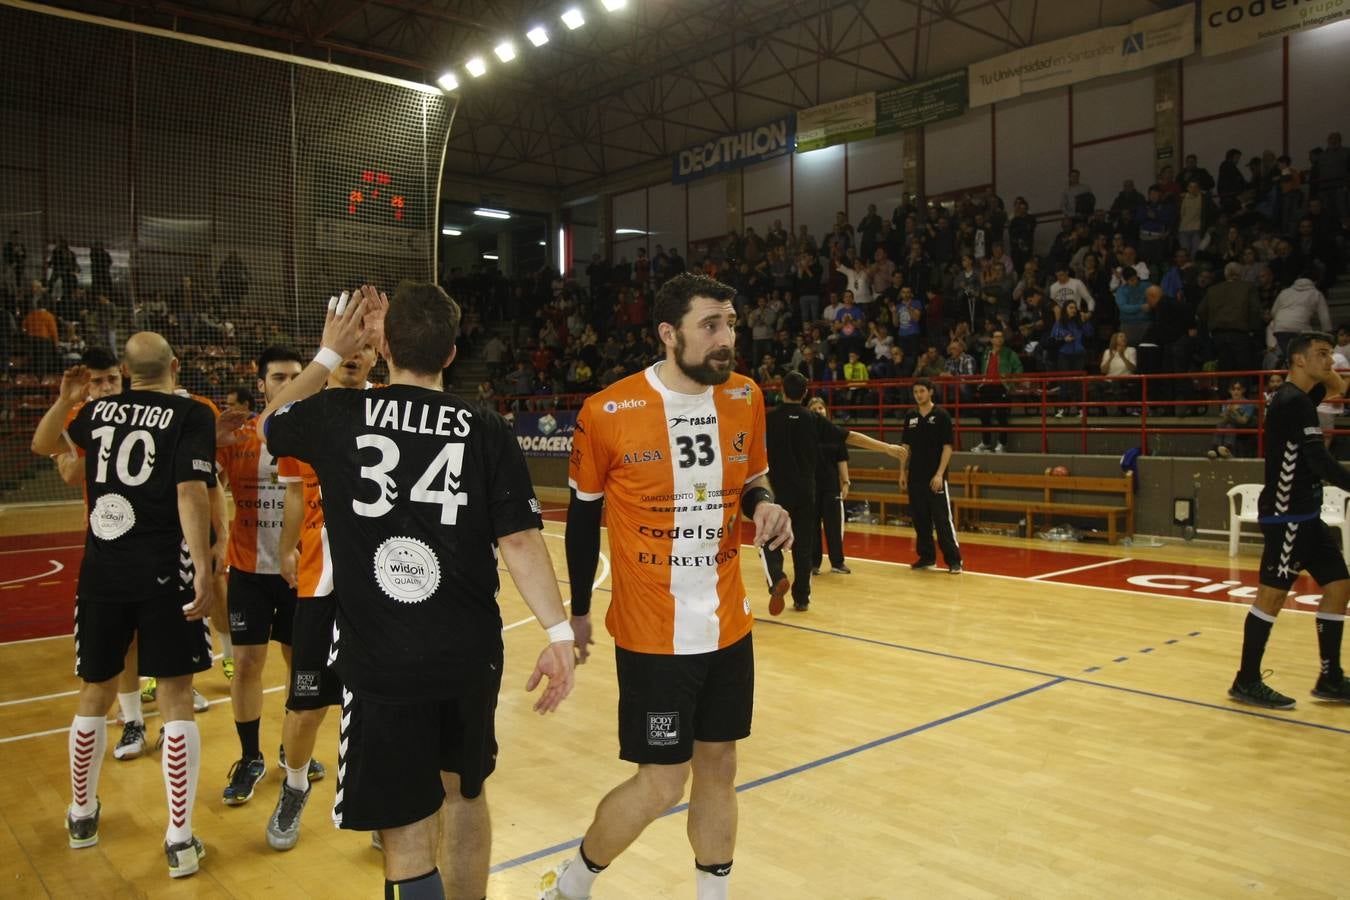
[952,466,1134,544]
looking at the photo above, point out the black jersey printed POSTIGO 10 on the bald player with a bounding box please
[66,390,216,603]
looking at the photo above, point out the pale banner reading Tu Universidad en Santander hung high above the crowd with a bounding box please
[969,0,1193,107]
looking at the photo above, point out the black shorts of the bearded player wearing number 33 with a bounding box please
[614,634,755,765]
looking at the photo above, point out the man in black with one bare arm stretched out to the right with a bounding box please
[764,372,905,613]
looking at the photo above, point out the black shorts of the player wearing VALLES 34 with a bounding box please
[333,661,502,831]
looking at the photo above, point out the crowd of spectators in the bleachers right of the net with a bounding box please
[480,134,1350,431]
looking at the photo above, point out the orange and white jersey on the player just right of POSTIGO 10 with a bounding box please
[216,421,286,575]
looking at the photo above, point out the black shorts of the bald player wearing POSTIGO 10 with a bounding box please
[74,591,211,684]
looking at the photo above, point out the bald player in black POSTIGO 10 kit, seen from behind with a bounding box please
[32,332,216,878]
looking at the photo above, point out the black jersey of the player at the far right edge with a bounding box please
[1257,382,1327,524]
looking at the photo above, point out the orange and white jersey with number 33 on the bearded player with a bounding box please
[567,363,768,654]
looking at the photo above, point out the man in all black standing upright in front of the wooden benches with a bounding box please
[896,378,961,575]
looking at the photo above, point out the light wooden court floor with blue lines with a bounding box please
[0,504,1350,900]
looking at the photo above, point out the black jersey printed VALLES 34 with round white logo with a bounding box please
[267,385,543,702]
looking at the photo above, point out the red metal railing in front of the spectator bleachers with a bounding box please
[497,370,1296,456]
